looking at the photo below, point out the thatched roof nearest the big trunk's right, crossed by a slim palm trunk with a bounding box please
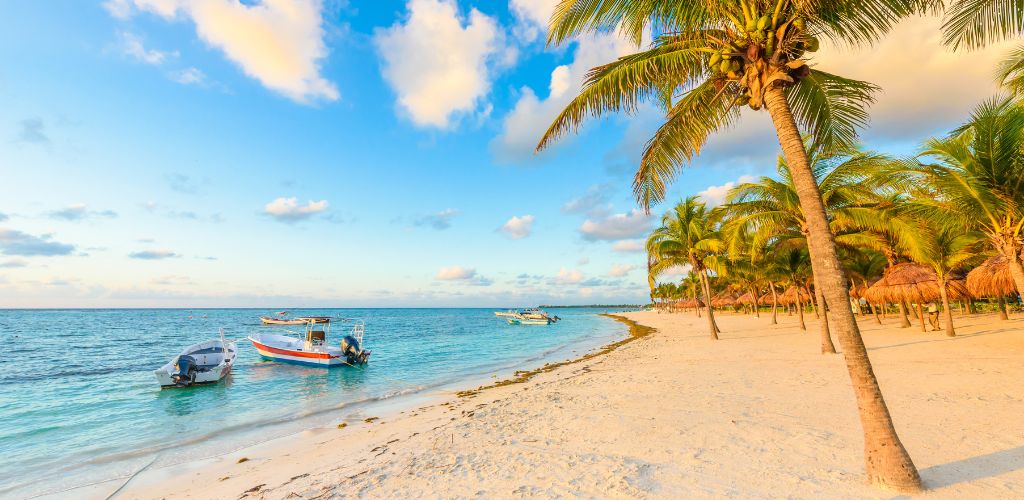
[863,262,971,303]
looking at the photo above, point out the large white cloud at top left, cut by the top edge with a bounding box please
[110,0,338,102]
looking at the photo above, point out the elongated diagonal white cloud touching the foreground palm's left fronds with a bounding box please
[490,27,637,163]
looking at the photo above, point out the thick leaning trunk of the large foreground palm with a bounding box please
[765,84,921,492]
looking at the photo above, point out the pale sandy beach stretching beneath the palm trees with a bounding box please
[101,313,1024,499]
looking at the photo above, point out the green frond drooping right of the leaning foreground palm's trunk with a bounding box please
[786,70,879,151]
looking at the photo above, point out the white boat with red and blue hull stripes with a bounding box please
[249,321,370,368]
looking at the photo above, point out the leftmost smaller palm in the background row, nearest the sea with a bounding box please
[646,196,725,340]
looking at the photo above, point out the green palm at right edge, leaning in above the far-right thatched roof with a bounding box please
[897,97,1024,297]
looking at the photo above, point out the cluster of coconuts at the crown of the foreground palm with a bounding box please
[708,5,818,110]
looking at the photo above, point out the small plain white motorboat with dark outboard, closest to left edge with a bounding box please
[153,331,238,387]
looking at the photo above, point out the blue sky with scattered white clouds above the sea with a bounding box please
[0,0,1007,308]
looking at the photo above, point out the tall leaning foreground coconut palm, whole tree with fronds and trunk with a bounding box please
[538,0,921,491]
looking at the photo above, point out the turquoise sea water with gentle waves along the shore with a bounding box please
[0,308,626,497]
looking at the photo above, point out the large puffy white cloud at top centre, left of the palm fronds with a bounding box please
[374,0,508,129]
